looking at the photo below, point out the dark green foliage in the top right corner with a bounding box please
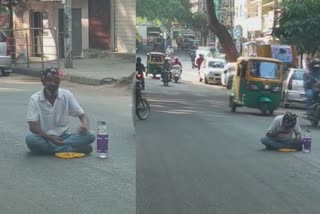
[275,0,320,54]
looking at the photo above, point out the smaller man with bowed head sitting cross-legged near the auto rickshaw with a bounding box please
[261,112,302,151]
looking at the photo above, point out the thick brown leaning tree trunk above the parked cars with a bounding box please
[206,0,239,62]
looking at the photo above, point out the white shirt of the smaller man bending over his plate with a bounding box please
[267,115,301,141]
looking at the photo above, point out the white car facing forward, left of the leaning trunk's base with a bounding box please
[199,58,225,84]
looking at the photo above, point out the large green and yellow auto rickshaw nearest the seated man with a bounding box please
[229,57,283,115]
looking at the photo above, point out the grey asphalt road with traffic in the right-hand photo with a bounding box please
[136,50,320,214]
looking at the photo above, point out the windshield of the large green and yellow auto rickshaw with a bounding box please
[250,61,280,79]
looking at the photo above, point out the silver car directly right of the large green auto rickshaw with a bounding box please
[282,68,307,108]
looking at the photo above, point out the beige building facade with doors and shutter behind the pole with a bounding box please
[14,0,136,61]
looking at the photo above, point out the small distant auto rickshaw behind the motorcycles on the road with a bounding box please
[146,52,166,77]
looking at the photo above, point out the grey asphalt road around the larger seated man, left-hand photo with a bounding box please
[0,75,136,214]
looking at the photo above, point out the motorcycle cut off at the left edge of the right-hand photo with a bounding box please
[136,80,150,120]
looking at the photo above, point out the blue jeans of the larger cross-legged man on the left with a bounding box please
[26,131,96,154]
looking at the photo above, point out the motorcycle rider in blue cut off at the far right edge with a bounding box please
[304,58,320,115]
